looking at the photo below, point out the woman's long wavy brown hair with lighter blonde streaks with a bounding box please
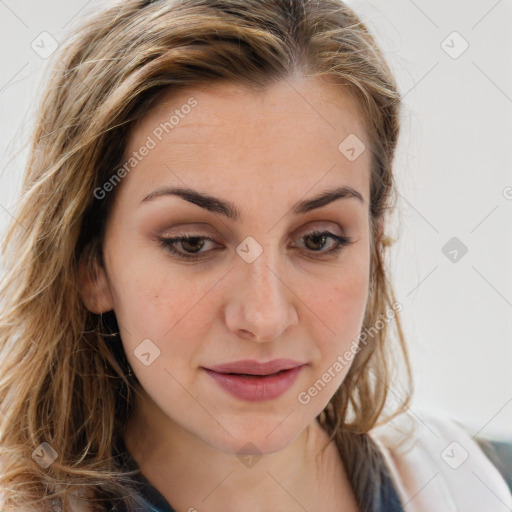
[0,0,412,510]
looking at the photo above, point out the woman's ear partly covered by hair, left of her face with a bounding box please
[78,250,114,314]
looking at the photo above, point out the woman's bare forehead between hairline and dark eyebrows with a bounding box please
[118,78,370,204]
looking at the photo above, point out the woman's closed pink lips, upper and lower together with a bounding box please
[204,359,306,402]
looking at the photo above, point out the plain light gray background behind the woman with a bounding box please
[0,0,512,437]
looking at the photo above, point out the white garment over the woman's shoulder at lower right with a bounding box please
[370,409,512,512]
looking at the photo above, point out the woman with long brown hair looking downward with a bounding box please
[0,0,512,512]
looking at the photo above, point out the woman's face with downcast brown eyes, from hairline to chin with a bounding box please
[84,79,370,453]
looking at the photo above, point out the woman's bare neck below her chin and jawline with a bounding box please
[125,386,355,512]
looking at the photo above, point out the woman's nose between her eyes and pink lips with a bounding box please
[225,251,298,342]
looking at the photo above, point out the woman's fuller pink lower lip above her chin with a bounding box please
[205,365,304,402]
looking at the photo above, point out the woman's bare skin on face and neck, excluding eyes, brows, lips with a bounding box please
[82,78,376,512]
